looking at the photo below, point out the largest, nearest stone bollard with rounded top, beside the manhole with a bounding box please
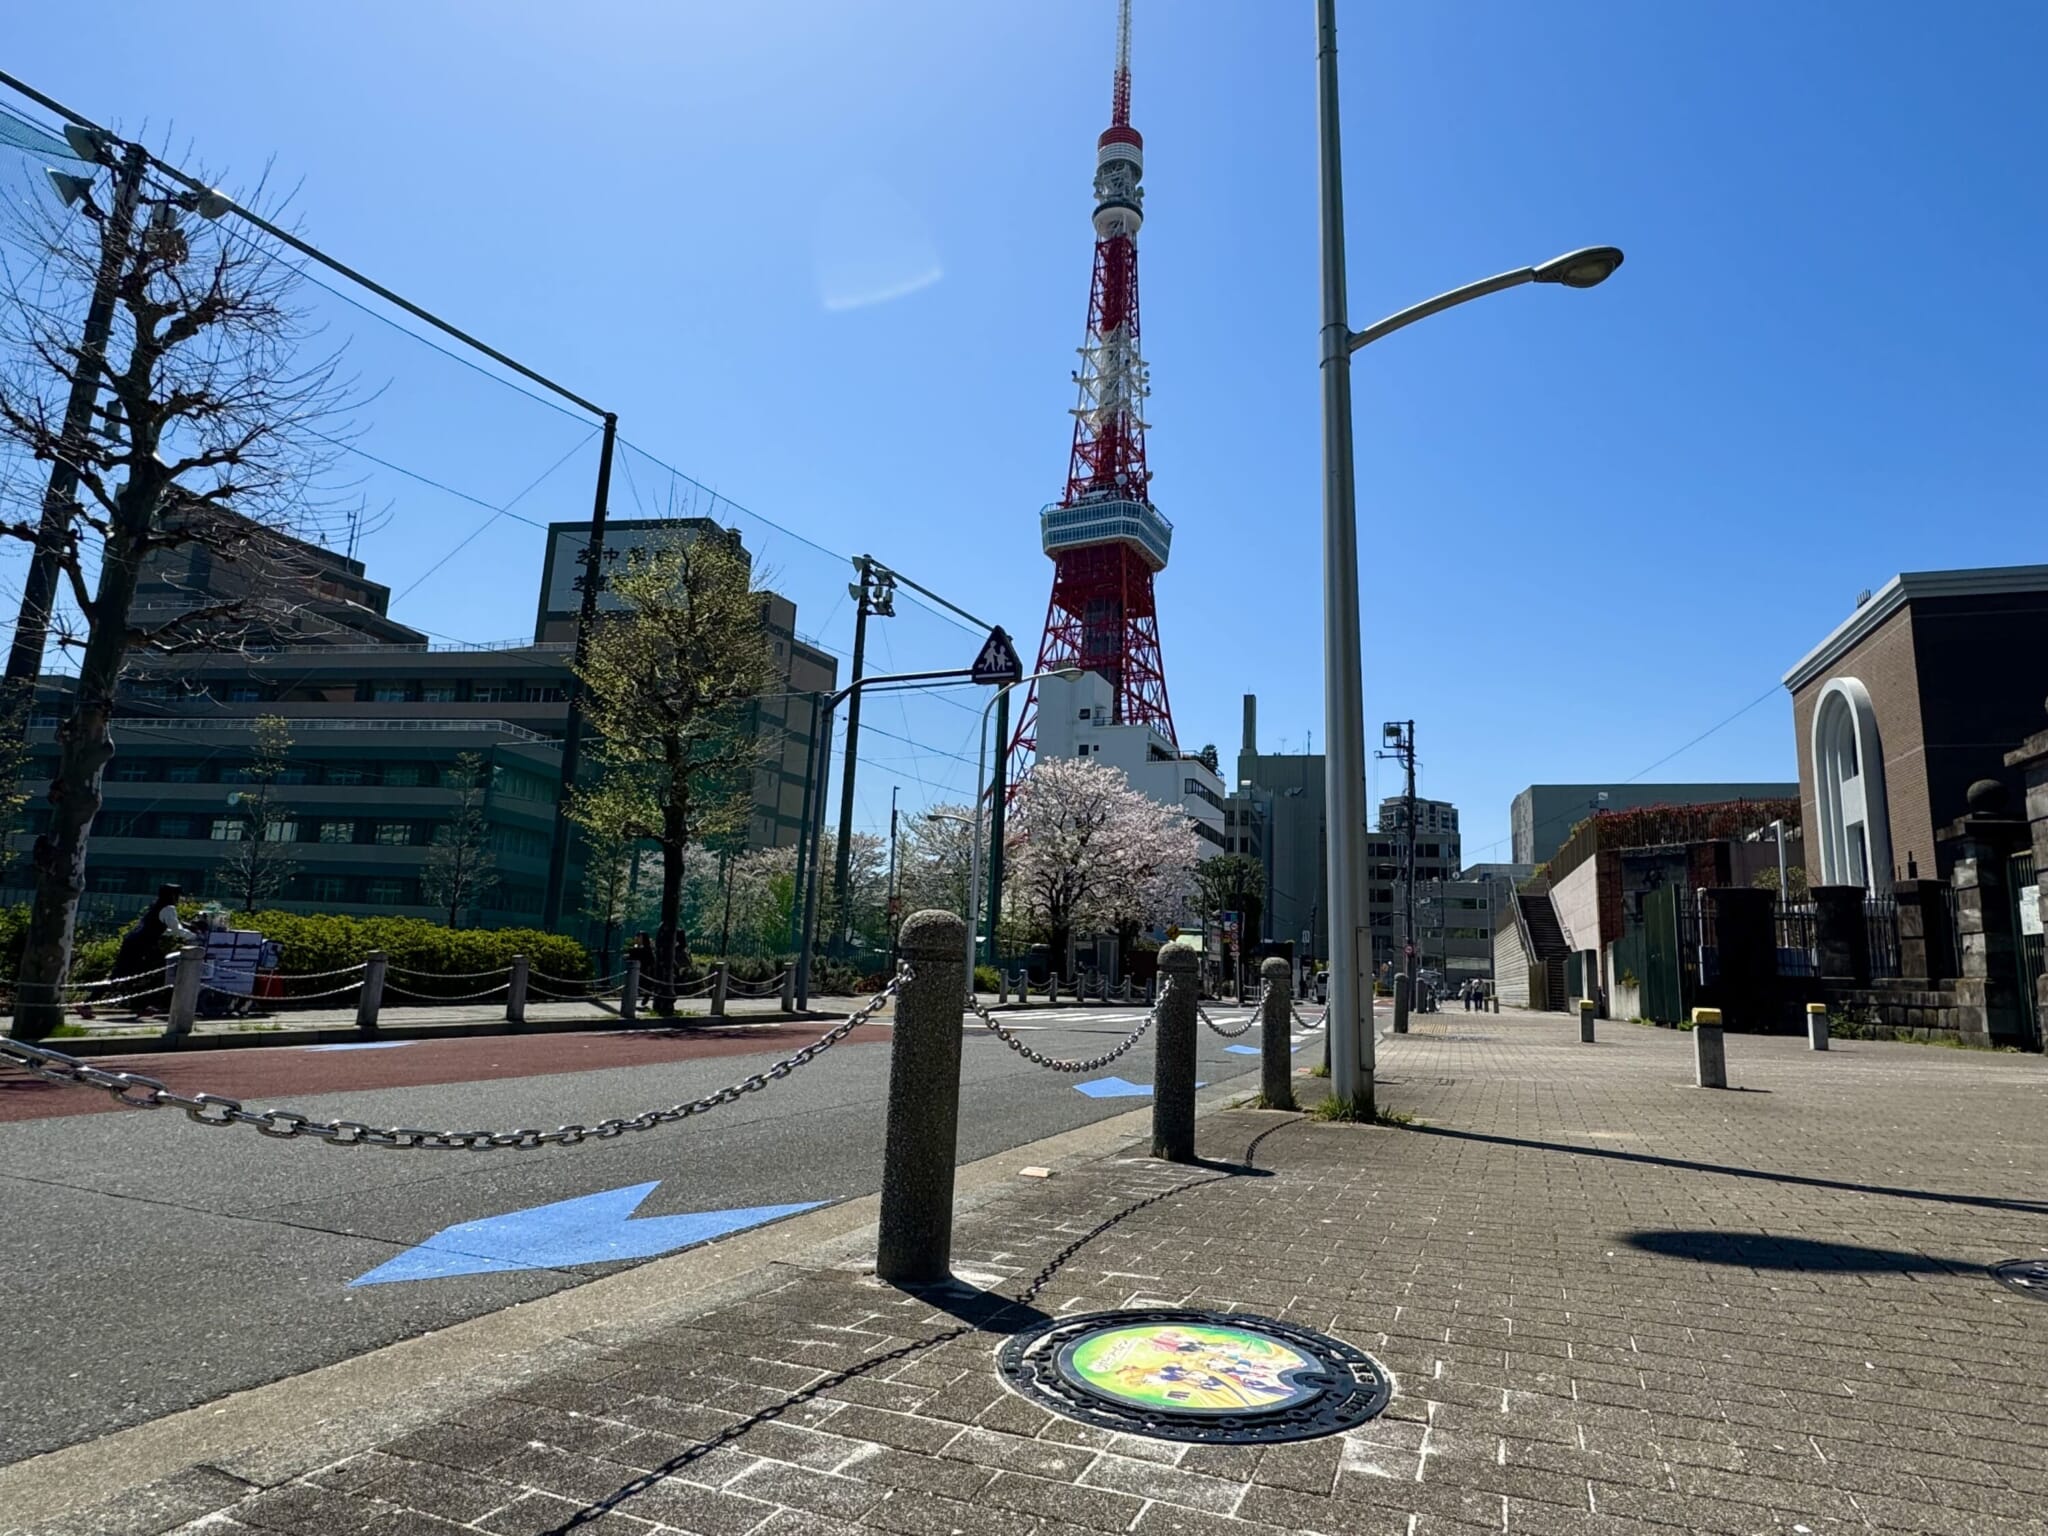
[874,911,967,1286]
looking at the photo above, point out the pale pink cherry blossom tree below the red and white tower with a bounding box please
[1008,758,1198,987]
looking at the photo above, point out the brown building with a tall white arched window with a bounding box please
[1784,565,2048,891]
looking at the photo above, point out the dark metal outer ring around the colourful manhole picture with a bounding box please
[995,1307,1393,1446]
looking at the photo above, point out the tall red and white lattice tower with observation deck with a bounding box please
[1012,0,1176,768]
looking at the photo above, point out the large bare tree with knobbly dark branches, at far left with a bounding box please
[0,145,344,1038]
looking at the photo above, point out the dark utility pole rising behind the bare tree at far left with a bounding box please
[4,133,150,704]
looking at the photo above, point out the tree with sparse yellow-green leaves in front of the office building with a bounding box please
[569,530,776,1012]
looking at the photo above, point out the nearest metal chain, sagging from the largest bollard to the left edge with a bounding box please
[0,965,911,1151]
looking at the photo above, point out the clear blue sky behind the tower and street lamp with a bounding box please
[0,0,2048,860]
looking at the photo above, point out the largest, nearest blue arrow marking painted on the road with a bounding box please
[348,1187,823,1286]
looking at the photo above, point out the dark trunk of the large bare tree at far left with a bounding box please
[14,505,160,1040]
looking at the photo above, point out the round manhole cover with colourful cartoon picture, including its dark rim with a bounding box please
[997,1309,1393,1444]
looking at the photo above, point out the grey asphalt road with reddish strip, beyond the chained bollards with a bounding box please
[0,1008,1309,1464]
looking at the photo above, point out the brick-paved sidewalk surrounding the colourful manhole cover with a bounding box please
[24,1014,2048,1536]
